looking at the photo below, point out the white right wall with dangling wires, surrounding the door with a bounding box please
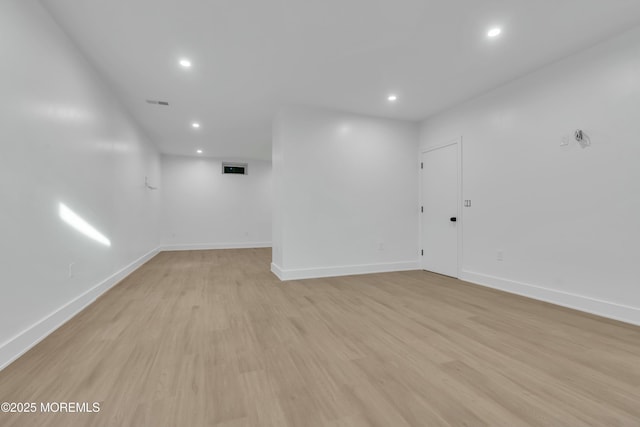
[421,28,640,323]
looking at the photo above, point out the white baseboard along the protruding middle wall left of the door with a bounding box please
[271,261,420,281]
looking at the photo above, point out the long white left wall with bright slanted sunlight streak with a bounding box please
[0,0,160,368]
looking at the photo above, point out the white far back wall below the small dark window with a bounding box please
[160,155,272,250]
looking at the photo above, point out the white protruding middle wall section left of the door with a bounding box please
[272,107,418,279]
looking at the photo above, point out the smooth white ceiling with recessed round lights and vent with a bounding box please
[42,0,640,159]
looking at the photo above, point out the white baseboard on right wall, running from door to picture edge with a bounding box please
[460,271,640,325]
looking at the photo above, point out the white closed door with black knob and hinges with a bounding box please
[421,141,460,277]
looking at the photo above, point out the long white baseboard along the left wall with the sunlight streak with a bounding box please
[0,249,159,371]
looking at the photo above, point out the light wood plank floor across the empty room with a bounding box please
[0,249,640,427]
